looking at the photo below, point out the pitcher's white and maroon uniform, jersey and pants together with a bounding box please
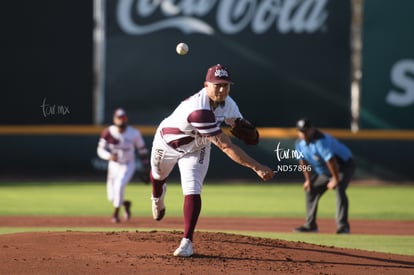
[151,88,242,195]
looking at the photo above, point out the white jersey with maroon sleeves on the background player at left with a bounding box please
[98,125,148,163]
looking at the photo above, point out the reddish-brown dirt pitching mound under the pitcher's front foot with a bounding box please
[0,231,414,274]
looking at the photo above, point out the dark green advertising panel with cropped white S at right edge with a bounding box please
[360,0,414,130]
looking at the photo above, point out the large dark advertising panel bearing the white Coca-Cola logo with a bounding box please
[104,0,350,128]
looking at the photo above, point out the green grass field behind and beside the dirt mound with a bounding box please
[0,182,414,255]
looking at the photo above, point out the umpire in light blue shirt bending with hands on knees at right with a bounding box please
[294,118,355,234]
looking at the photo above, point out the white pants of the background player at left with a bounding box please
[106,161,135,208]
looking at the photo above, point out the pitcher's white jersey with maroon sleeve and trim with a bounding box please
[159,88,242,153]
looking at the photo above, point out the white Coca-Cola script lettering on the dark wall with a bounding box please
[116,0,328,35]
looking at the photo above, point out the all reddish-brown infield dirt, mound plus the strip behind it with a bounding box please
[0,217,414,274]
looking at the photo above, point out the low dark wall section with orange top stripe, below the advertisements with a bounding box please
[0,125,414,181]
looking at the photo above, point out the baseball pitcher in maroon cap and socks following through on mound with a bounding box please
[150,64,274,257]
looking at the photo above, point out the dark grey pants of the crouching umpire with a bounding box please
[305,159,355,229]
